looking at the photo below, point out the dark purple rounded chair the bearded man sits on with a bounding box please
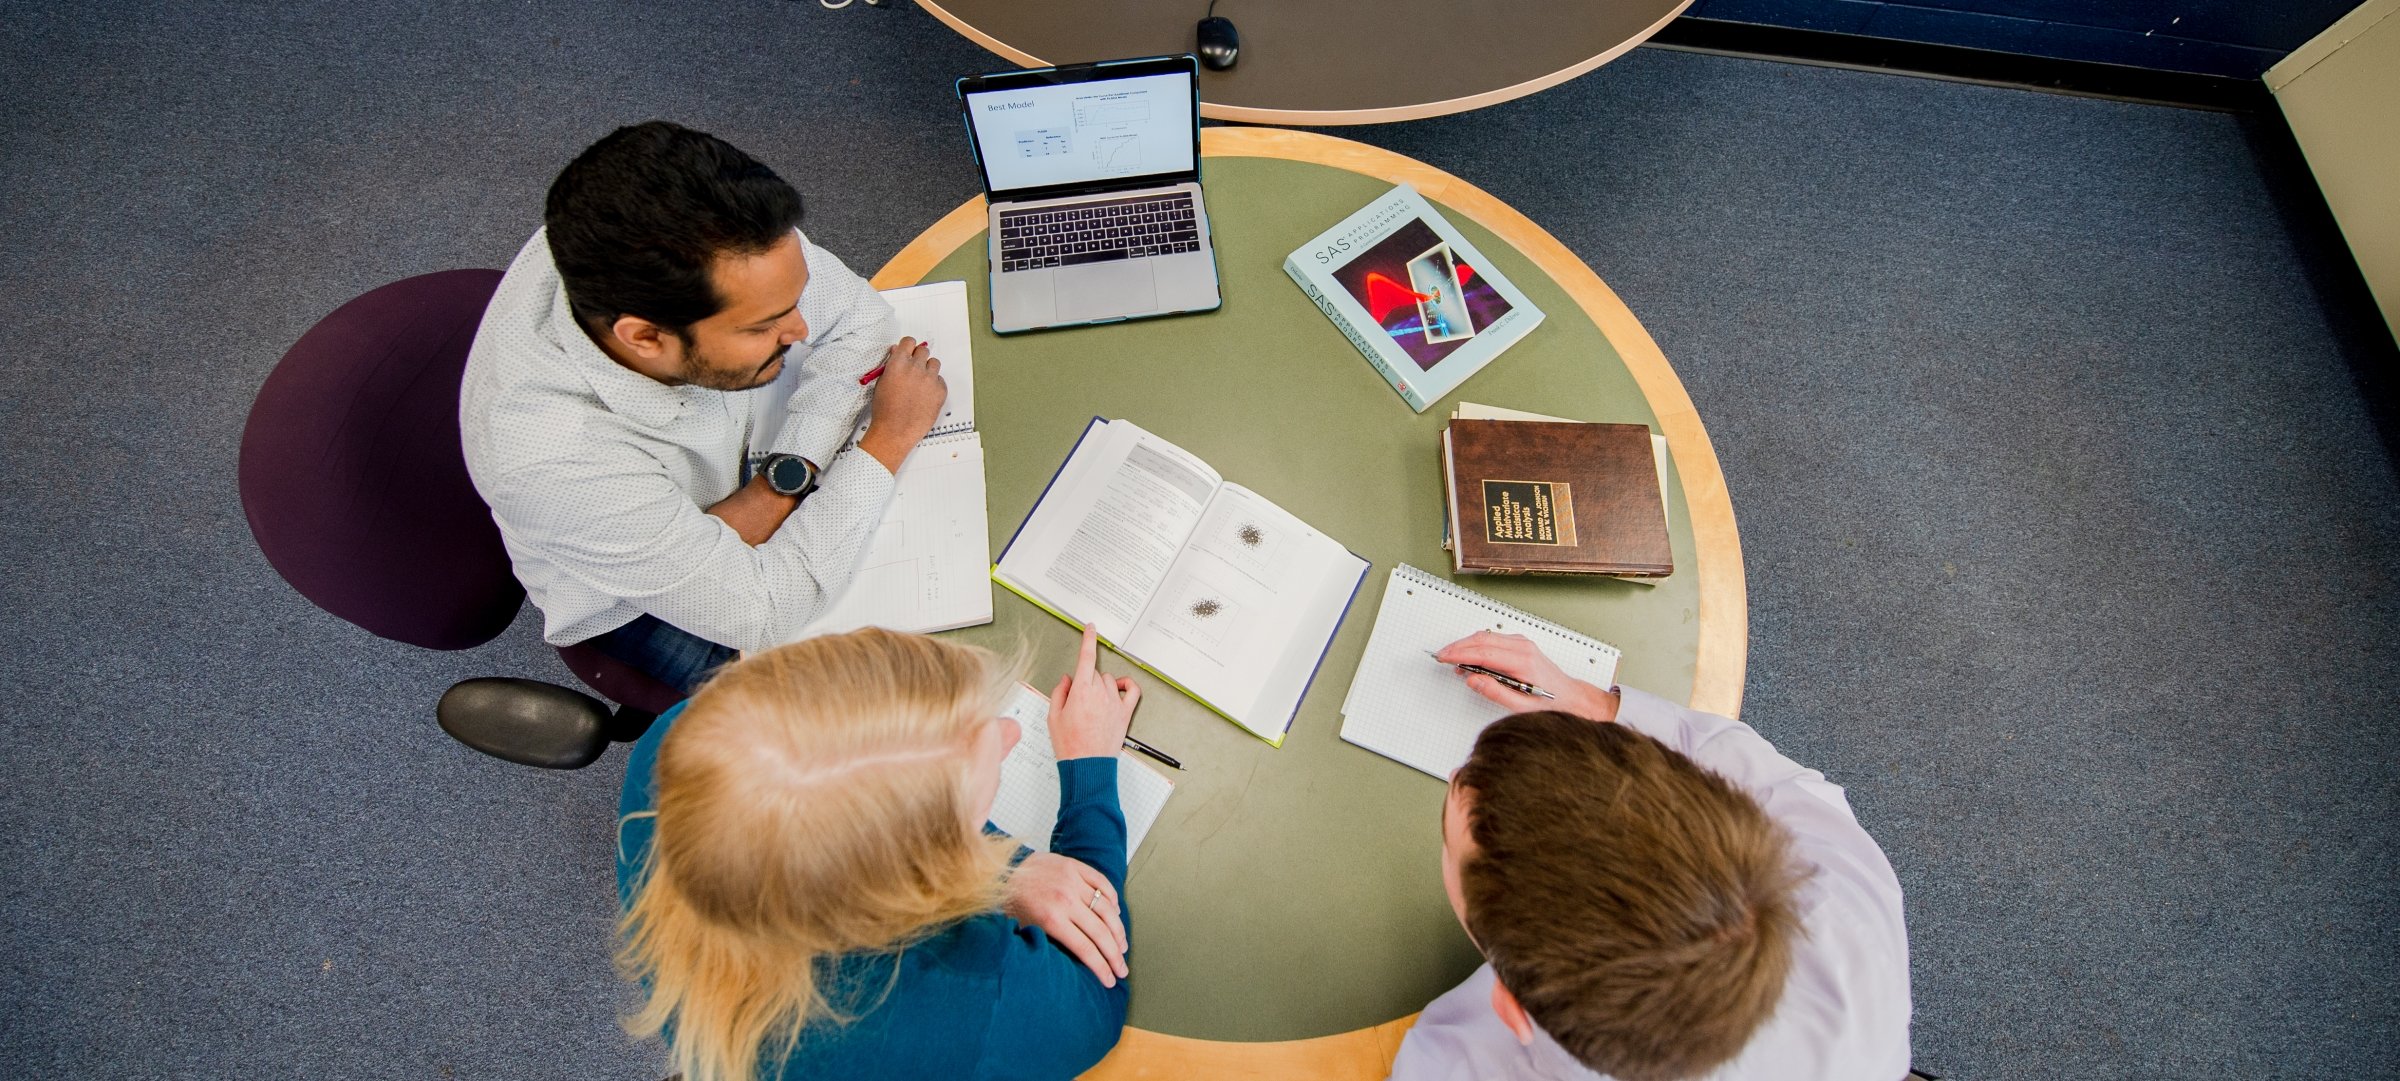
[240,269,679,766]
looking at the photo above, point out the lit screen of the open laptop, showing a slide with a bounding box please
[960,60,1198,197]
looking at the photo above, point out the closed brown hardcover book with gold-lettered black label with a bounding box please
[1442,420,1675,577]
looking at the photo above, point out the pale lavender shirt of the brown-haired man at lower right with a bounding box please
[1392,687,1910,1081]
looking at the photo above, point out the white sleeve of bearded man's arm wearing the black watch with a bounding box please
[773,238,900,468]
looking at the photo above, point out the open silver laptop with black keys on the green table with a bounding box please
[958,55,1222,334]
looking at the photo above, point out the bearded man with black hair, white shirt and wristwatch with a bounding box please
[458,120,946,689]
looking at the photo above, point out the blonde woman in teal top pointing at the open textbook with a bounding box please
[617,629,1140,1081]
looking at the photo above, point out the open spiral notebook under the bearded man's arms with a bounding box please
[797,281,991,639]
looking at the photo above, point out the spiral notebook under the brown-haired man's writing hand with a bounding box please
[1342,565,1618,781]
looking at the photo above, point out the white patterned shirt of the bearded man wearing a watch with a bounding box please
[458,231,898,651]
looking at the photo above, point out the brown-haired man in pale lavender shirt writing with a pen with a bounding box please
[1392,632,1908,1081]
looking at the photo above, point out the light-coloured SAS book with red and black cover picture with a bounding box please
[1284,185,1541,413]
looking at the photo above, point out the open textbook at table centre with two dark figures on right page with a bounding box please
[991,418,1368,747]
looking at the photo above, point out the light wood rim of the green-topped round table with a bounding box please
[871,124,1750,1081]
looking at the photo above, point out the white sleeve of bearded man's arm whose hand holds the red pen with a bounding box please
[490,444,893,651]
